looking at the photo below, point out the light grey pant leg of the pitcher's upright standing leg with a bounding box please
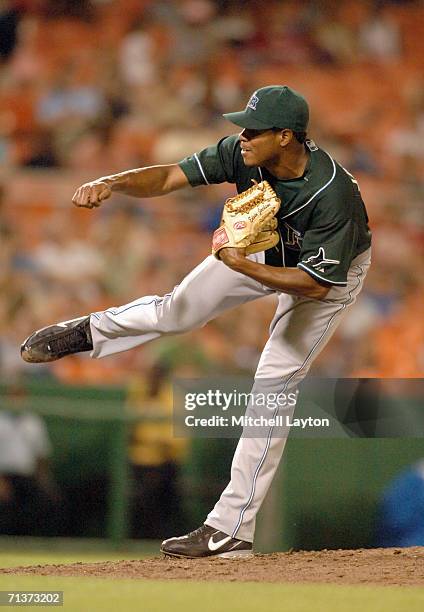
[205,253,370,542]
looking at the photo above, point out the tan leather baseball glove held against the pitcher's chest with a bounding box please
[212,181,281,259]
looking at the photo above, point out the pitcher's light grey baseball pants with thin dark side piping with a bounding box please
[90,250,370,542]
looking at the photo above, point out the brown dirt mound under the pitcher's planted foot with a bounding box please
[0,547,424,586]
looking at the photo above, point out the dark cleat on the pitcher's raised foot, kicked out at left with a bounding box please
[21,316,93,363]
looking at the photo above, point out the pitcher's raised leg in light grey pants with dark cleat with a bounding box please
[21,253,272,363]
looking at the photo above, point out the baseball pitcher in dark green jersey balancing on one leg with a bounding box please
[21,86,371,558]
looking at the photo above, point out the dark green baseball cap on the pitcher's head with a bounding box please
[224,85,309,132]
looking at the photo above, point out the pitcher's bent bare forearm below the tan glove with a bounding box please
[220,248,330,300]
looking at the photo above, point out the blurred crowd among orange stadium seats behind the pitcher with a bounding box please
[0,0,424,384]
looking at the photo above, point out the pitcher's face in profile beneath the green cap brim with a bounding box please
[239,128,282,166]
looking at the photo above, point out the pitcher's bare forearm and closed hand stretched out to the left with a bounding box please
[72,164,189,208]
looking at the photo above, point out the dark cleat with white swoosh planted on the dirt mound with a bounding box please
[160,525,253,559]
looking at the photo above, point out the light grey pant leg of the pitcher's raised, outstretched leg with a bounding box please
[90,253,273,357]
